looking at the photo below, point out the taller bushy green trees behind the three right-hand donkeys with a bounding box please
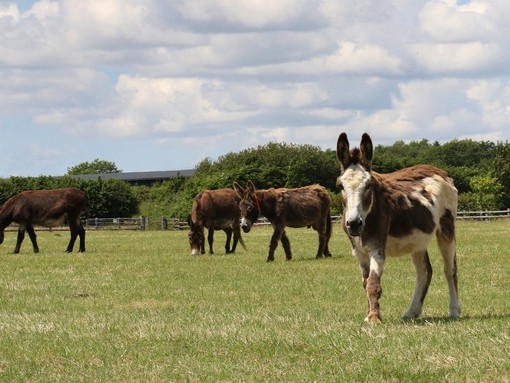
[142,140,510,217]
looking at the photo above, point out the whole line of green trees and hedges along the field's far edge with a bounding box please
[0,139,510,219]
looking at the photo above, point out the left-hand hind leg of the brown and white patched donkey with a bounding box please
[404,249,432,318]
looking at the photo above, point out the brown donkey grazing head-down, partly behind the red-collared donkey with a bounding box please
[188,189,246,255]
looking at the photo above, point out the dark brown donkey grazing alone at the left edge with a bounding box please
[0,188,87,254]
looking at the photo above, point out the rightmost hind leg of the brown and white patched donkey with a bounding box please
[437,235,461,318]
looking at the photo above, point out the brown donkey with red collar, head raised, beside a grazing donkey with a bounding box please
[234,181,331,262]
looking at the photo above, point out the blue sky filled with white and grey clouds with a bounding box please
[0,0,510,177]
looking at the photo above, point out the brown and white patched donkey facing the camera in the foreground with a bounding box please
[337,133,461,322]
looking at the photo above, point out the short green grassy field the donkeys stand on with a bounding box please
[0,220,510,382]
